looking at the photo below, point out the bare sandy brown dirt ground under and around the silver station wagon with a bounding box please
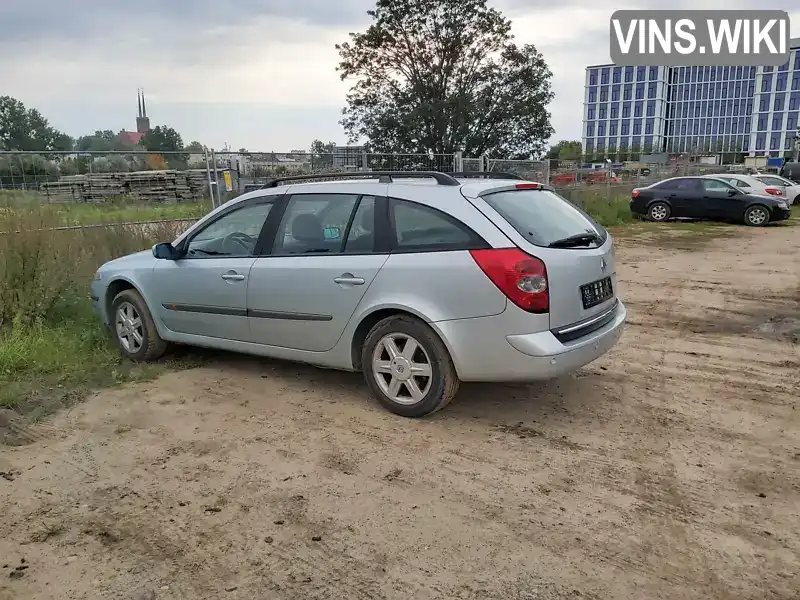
[0,227,800,600]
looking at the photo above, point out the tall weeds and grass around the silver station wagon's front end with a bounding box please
[0,194,210,443]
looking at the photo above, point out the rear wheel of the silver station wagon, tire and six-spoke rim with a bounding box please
[361,315,459,418]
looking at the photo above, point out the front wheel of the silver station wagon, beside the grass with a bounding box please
[110,290,167,362]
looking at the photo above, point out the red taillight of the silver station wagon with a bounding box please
[470,248,550,313]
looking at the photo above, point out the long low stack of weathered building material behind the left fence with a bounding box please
[41,170,206,202]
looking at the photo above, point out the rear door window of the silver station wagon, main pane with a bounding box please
[273,194,358,255]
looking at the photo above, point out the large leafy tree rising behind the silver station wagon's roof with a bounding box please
[336,0,553,158]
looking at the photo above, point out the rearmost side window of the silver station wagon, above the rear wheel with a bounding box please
[390,199,485,252]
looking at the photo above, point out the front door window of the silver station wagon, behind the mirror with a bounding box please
[186,201,273,258]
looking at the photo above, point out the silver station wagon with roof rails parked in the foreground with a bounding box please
[92,172,626,417]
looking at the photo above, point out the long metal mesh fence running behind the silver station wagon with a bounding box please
[0,147,760,206]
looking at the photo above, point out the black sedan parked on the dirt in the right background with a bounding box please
[631,177,792,227]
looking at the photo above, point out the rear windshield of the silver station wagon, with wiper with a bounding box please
[483,190,607,246]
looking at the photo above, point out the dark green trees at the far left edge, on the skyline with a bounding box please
[0,96,73,152]
